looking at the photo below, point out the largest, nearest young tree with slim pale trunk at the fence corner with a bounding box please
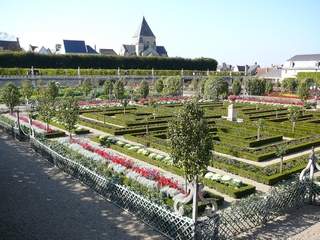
[168,101,213,220]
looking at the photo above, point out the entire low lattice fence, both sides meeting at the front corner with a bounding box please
[0,118,320,240]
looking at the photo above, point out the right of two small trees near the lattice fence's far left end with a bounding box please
[58,97,79,139]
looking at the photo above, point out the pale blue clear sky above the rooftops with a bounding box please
[0,0,320,66]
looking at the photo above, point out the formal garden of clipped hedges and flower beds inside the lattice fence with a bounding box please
[0,73,320,239]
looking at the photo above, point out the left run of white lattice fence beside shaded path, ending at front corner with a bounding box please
[31,139,195,240]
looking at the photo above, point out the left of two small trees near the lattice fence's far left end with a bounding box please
[37,92,56,132]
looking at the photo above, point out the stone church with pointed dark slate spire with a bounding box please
[120,17,168,57]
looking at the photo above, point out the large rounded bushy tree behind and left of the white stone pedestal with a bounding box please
[204,77,228,100]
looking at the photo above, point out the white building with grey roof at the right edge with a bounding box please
[281,54,320,79]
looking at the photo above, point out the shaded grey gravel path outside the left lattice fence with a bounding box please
[0,131,164,240]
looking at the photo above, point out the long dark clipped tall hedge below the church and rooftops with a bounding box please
[0,53,217,71]
